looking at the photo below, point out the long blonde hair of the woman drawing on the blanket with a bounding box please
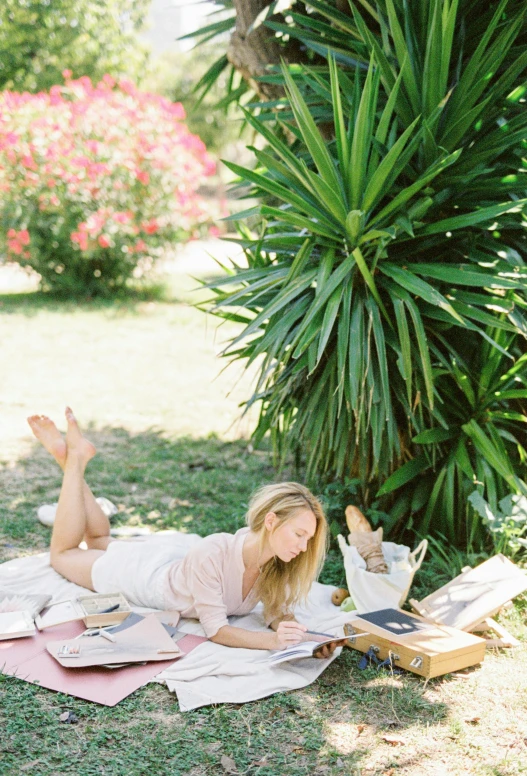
[246,482,327,620]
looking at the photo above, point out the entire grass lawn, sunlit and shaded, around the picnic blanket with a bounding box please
[0,239,527,776]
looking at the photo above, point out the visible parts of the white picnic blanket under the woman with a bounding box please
[0,552,356,711]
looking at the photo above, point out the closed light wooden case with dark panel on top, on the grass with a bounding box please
[346,609,485,679]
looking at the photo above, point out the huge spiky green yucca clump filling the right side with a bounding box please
[199,0,527,542]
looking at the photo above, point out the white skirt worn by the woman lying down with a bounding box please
[91,531,202,609]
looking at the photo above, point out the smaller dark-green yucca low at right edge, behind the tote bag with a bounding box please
[379,330,527,546]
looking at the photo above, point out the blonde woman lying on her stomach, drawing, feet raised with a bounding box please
[28,408,346,657]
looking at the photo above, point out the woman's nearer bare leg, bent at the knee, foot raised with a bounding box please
[50,408,105,590]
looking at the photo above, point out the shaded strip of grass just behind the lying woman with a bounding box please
[0,428,285,556]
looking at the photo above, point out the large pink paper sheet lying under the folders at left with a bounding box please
[0,622,207,706]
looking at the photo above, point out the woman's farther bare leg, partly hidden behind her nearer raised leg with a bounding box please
[27,415,113,550]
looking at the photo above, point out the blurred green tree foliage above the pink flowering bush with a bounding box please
[0,0,150,92]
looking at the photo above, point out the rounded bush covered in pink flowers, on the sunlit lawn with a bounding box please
[0,71,219,294]
